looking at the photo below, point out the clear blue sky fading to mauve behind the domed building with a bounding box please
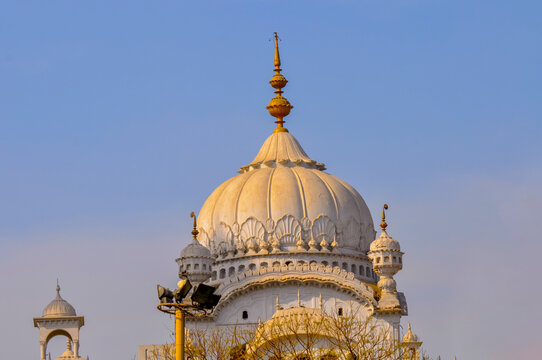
[0,0,542,359]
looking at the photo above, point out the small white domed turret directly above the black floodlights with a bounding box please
[177,212,214,283]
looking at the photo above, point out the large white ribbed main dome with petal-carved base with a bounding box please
[198,132,375,252]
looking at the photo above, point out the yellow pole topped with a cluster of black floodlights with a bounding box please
[156,280,220,360]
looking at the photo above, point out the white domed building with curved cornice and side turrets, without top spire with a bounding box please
[177,132,407,339]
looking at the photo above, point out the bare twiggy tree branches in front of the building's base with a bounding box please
[149,308,436,360]
